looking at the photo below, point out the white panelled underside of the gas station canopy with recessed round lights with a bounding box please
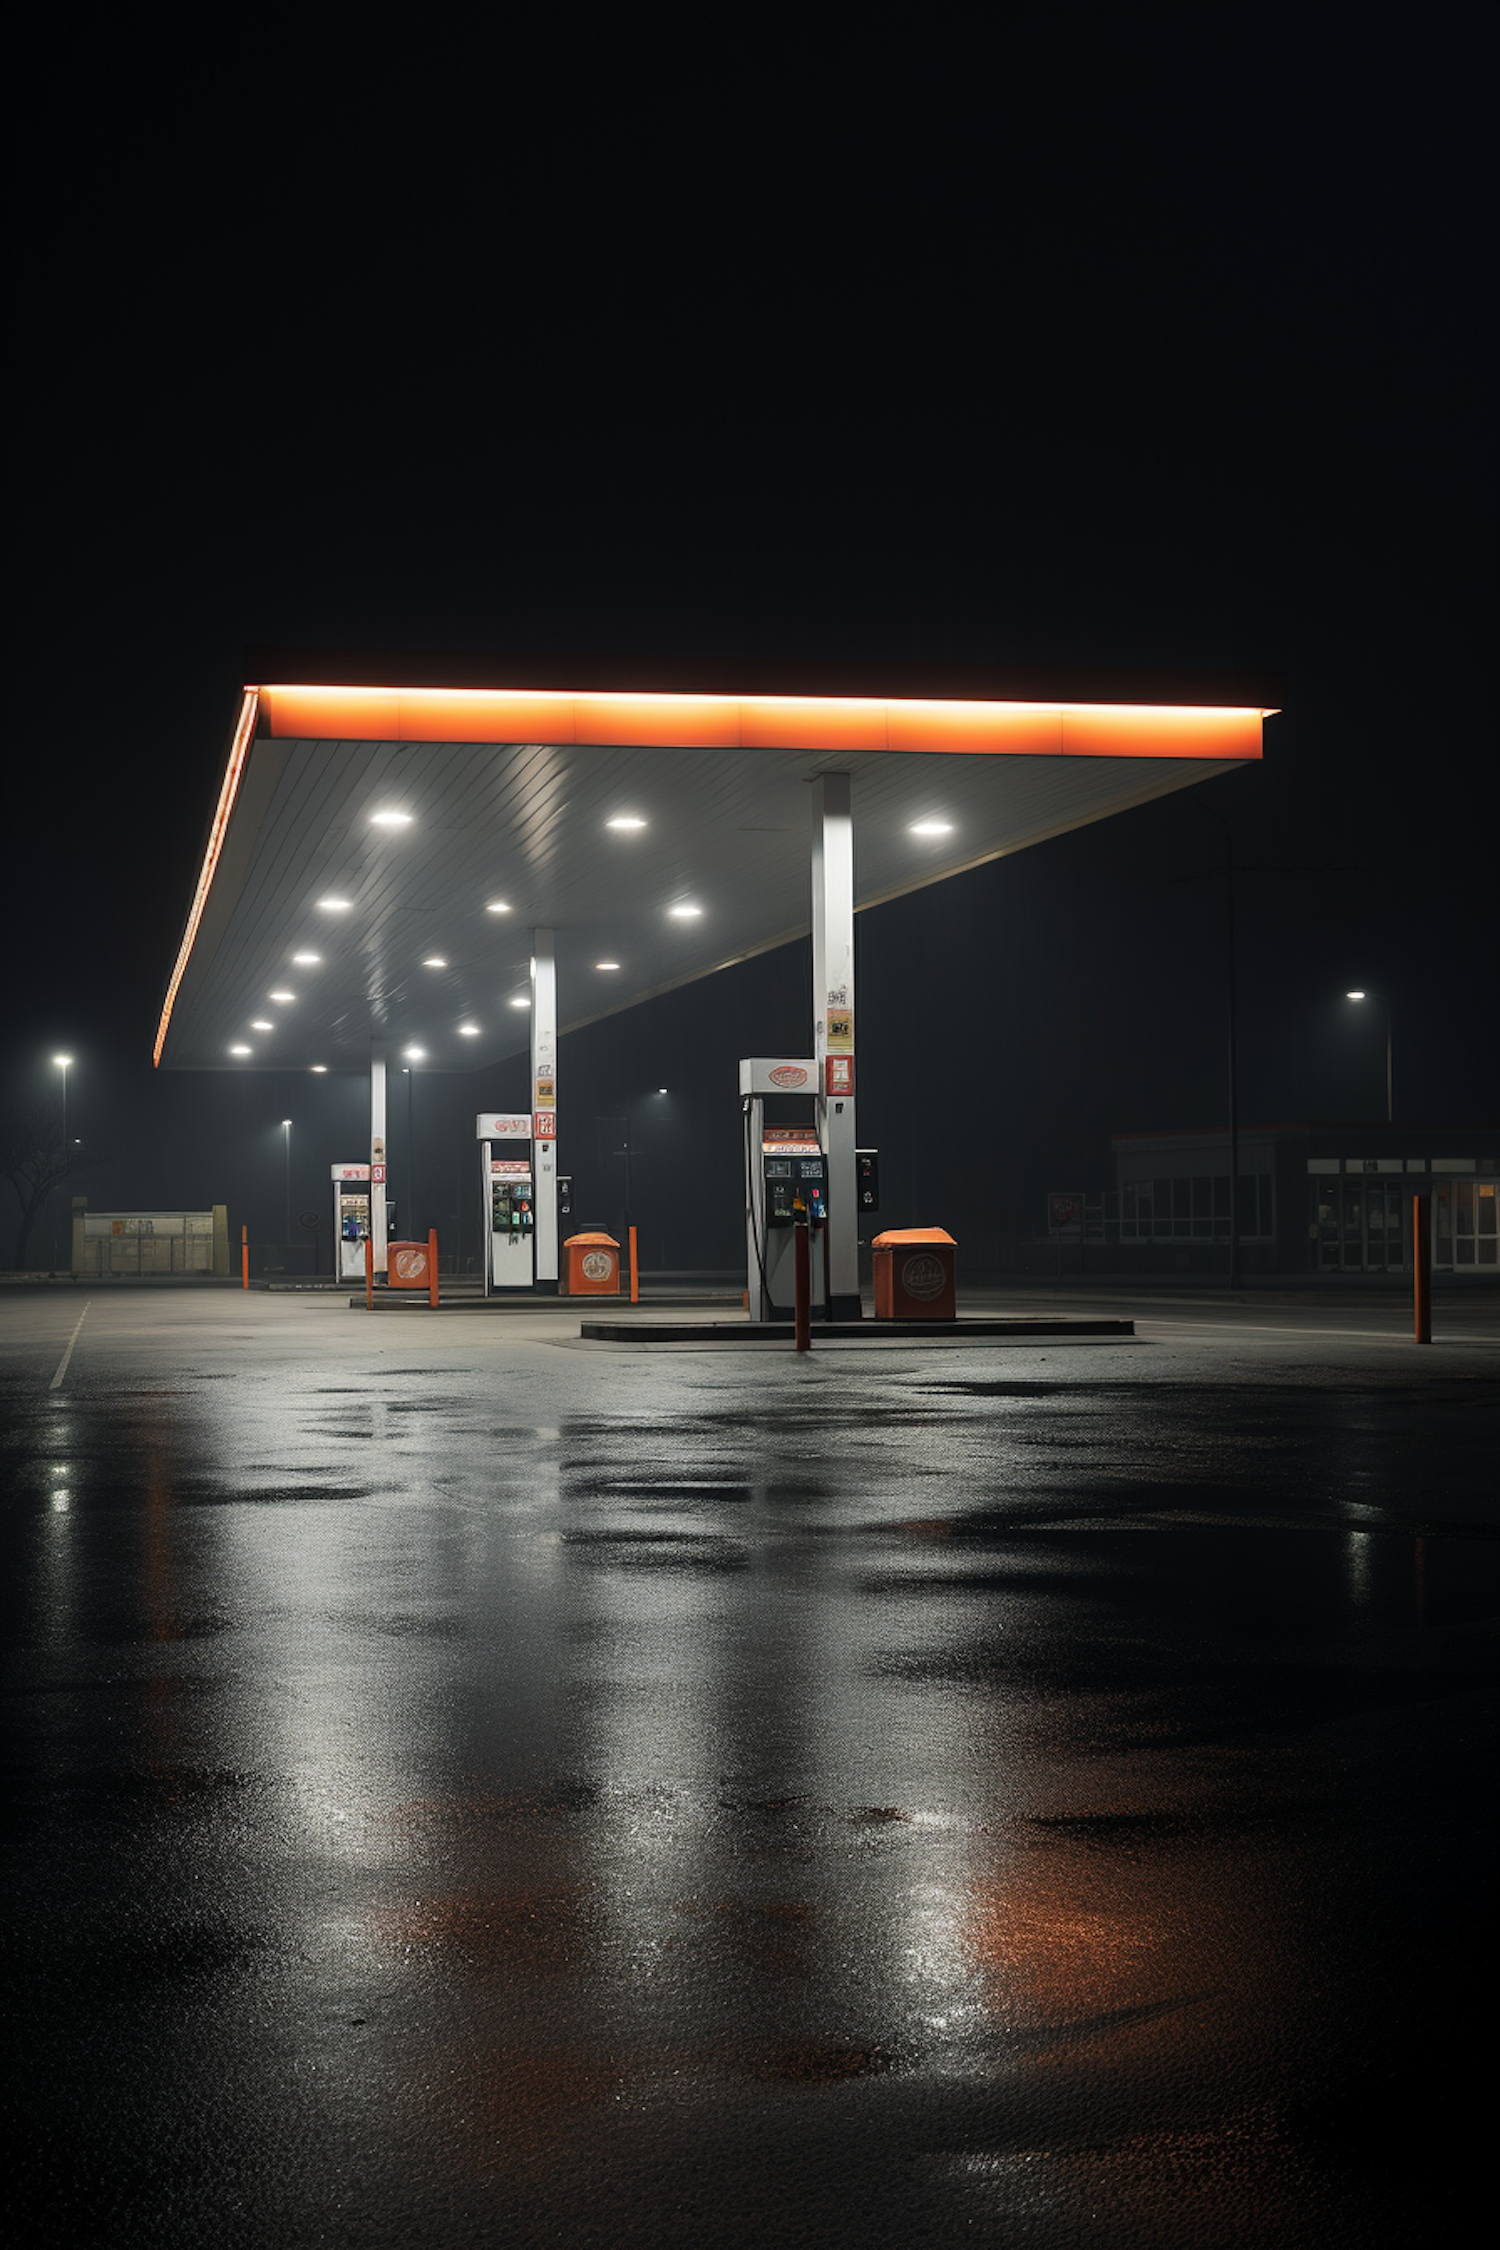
[157,666,1259,1069]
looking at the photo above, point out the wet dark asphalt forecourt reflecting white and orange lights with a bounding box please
[0,1289,1500,2250]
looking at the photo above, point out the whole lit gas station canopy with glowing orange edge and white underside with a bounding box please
[155,655,1275,1071]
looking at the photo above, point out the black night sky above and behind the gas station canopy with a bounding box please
[0,52,1500,1265]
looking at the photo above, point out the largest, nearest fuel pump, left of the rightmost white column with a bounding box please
[740,1060,828,1321]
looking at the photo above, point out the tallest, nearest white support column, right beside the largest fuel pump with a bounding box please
[812,774,861,1321]
